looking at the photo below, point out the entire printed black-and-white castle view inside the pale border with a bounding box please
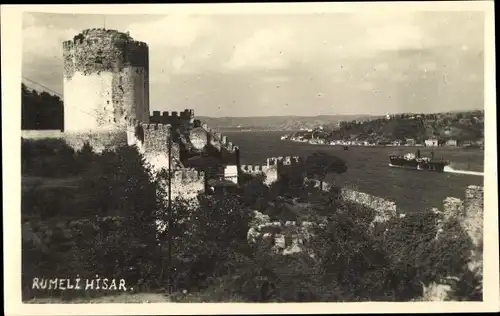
[4,1,498,310]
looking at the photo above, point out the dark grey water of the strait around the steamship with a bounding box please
[224,132,484,212]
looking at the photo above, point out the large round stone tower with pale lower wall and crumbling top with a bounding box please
[63,29,149,133]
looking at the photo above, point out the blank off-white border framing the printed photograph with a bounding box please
[1,1,500,315]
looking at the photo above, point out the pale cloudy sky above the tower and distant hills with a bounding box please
[22,9,484,117]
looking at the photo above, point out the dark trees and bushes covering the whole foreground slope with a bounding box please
[22,140,481,302]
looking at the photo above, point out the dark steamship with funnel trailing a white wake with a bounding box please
[389,150,450,172]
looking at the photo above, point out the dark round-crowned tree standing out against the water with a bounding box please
[305,151,347,187]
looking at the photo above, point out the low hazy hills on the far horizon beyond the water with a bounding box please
[196,114,379,131]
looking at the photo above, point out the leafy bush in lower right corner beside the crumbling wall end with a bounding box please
[376,211,478,299]
